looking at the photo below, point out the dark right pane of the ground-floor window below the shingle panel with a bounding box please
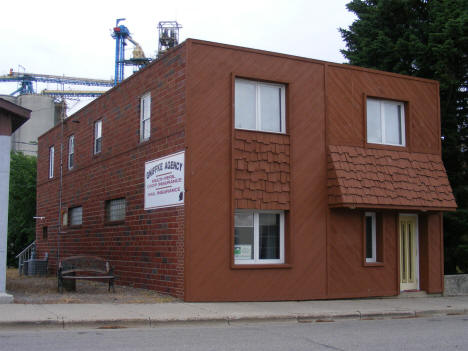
[259,213,280,260]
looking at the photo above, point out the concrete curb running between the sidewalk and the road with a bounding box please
[0,309,468,330]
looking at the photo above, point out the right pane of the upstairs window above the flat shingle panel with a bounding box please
[260,85,281,132]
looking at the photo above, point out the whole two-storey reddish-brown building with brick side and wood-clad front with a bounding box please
[37,39,456,301]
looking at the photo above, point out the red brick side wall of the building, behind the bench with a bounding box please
[36,46,186,298]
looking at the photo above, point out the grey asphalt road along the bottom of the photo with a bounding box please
[0,315,468,351]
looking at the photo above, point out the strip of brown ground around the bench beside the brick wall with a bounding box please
[6,268,177,304]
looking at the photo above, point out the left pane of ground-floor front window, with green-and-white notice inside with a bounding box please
[234,213,254,260]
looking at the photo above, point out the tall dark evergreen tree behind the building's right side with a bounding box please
[340,0,468,273]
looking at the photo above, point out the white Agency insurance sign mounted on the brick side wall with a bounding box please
[145,151,185,210]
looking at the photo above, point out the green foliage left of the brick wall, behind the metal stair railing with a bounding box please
[7,152,37,266]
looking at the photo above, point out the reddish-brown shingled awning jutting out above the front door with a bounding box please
[328,146,457,211]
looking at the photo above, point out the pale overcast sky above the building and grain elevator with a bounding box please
[0,0,355,112]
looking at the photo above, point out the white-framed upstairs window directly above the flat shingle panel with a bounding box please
[234,78,286,133]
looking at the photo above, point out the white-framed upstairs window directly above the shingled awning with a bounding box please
[367,98,406,146]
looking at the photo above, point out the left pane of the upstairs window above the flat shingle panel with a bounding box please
[234,81,257,130]
